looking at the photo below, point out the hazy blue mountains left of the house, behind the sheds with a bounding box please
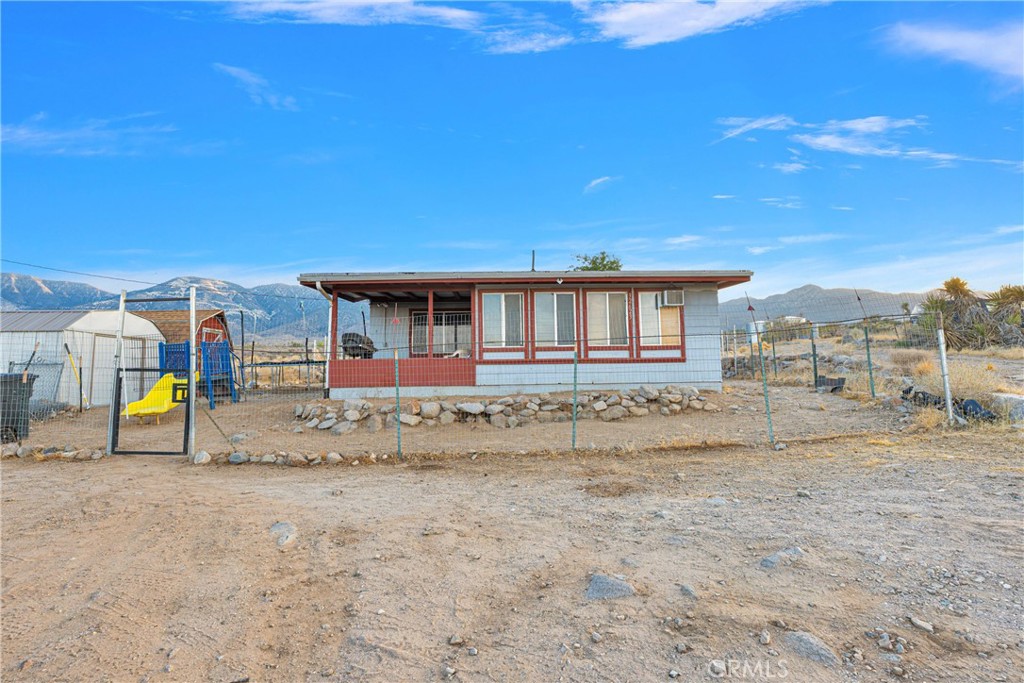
[0,273,366,341]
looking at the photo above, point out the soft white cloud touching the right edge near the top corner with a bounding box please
[886,22,1024,87]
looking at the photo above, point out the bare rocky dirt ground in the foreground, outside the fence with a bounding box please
[0,430,1024,683]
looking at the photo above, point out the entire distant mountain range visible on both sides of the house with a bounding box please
[0,272,928,339]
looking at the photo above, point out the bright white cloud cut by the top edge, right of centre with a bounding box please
[575,0,811,47]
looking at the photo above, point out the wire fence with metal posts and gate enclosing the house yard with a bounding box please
[0,290,1024,463]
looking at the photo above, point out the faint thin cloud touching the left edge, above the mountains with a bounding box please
[2,112,178,157]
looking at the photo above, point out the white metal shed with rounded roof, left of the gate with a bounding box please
[0,310,164,405]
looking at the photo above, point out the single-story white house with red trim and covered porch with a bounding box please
[298,270,753,398]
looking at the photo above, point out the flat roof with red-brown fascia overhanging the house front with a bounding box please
[298,270,754,301]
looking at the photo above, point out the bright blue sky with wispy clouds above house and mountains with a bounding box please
[0,1,1024,296]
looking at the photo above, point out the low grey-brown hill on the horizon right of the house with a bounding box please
[719,285,928,330]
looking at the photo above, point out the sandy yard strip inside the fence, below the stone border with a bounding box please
[29,381,906,456]
